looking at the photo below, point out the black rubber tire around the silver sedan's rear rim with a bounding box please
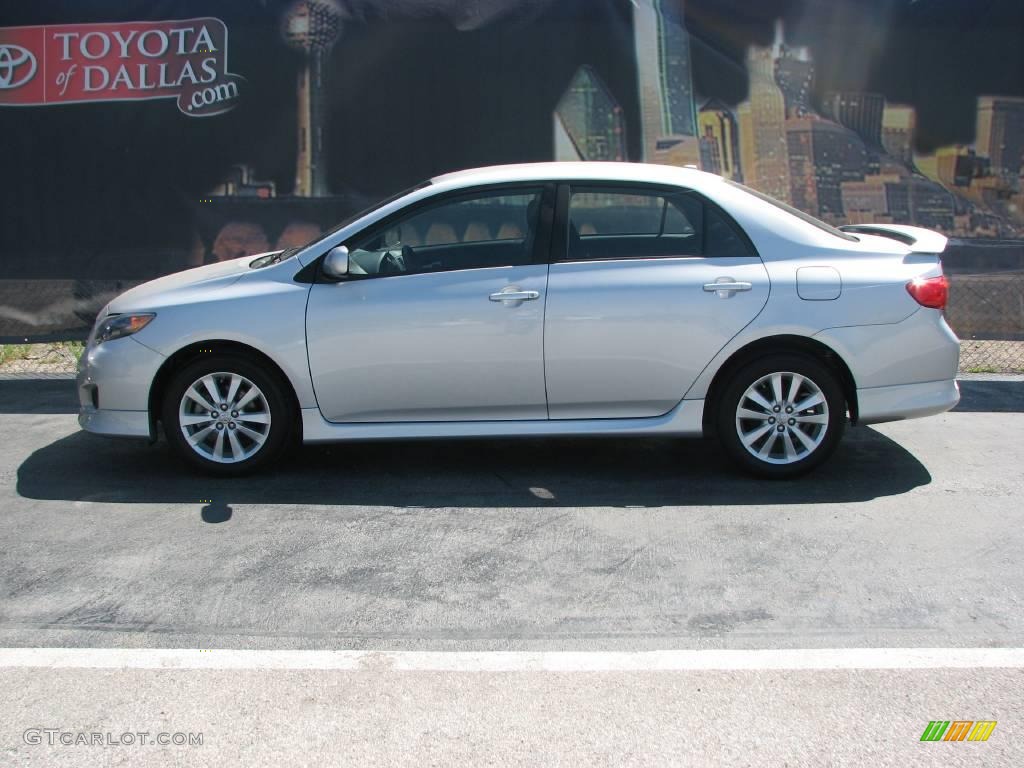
[716,352,846,479]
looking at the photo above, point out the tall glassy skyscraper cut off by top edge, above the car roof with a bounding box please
[633,0,697,160]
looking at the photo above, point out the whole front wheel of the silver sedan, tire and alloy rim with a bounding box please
[163,355,294,475]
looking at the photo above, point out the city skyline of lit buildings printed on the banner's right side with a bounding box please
[555,0,1024,238]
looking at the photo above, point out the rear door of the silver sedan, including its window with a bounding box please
[545,184,769,419]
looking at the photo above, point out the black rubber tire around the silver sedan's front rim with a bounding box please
[162,354,296,477]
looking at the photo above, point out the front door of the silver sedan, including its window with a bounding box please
[306,187,550,422]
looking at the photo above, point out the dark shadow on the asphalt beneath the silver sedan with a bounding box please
[17,427,931,512]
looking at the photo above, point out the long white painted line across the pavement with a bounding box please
[0,648,1024,673]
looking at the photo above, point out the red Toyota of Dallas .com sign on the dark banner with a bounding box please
[0,17,243,117]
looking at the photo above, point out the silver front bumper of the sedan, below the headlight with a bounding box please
[77,336,166,439]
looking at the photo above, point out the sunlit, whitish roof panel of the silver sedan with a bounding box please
[430,161,722,188]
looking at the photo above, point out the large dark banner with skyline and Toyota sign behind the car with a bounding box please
[0,0,1024,341]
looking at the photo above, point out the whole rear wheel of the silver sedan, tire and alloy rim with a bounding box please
[718,354,846,478]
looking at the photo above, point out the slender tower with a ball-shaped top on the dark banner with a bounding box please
[283,0,341,198]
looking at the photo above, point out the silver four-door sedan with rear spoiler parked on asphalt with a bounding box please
[78,163,959,477]
